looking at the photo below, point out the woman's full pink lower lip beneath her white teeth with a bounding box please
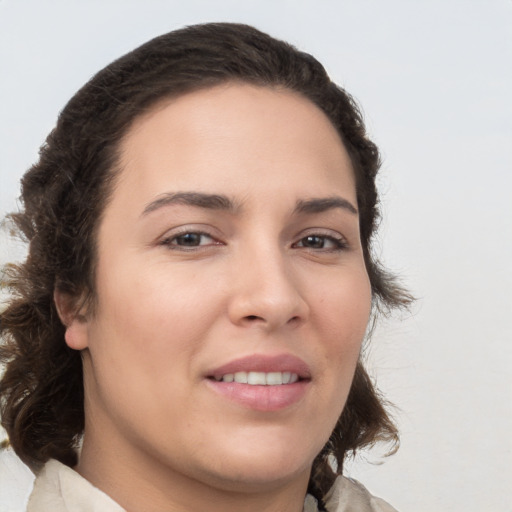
[207,379,309,411]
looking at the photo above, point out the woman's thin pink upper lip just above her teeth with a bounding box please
[207,354,311,379]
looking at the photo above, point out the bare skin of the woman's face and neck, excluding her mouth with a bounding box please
[56,84,370,512]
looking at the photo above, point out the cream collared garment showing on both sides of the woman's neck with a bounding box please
[27,460,396,512]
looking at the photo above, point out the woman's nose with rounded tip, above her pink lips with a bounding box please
[228,248,309,332]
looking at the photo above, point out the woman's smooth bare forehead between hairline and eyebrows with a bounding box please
[114,83,355,204]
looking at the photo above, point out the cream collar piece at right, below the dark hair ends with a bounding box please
[325,476,397,512]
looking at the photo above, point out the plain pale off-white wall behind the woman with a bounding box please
[0,0,512,512]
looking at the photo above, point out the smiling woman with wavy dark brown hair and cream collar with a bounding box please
[0,24,408,512]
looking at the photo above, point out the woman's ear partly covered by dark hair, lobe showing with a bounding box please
[53,290,89,350]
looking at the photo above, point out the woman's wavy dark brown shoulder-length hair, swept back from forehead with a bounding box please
[0,23,409,506]
